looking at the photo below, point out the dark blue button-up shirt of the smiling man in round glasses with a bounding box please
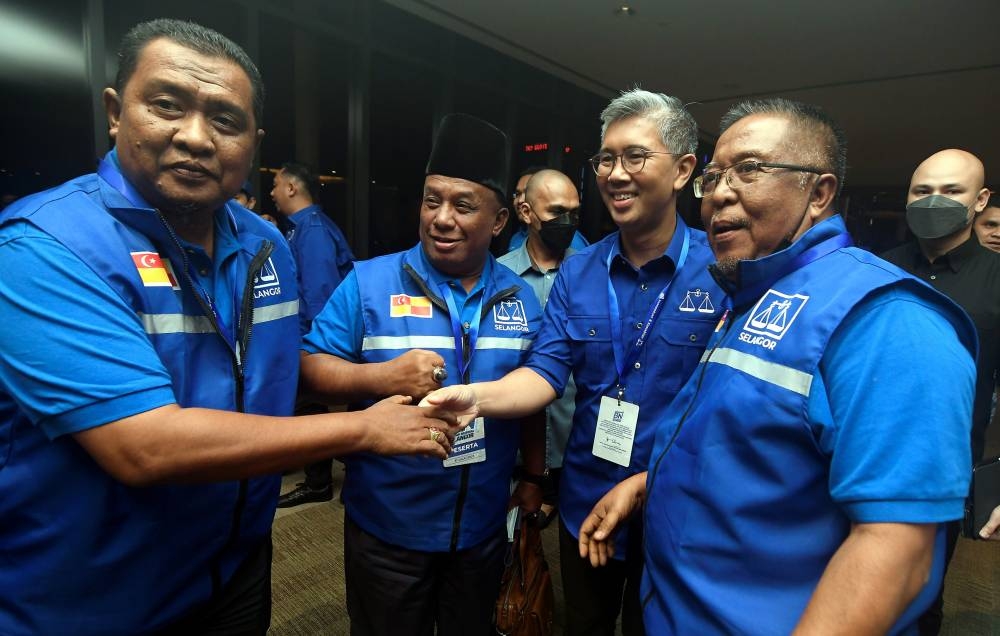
[526,217,724,558]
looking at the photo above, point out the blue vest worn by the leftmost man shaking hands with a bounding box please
[0,175,299,634]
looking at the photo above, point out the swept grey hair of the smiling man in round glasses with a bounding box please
[601,88,698,154]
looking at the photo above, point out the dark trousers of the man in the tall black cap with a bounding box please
[344,514,507,636]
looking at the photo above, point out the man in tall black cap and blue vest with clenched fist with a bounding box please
[302,114,545,636]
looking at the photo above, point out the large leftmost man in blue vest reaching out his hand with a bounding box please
[0,20,451,636]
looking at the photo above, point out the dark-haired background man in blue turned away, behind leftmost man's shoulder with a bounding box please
[271,161,354,508]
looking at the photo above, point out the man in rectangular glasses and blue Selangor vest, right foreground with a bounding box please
[580,99,976,634]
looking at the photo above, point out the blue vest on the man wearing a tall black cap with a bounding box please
[343,245,541,552]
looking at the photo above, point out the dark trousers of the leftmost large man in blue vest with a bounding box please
[159,536,271,636]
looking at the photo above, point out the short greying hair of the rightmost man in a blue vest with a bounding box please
[719,97,847,197]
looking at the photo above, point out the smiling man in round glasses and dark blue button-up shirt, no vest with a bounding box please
[428,89,723,636]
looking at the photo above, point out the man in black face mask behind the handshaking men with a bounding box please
[497,170,580,527]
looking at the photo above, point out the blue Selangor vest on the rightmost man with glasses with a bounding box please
[642,219,975,634]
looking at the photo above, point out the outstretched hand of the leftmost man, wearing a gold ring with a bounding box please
[360,395,464,459]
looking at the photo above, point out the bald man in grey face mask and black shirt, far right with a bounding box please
[882,149,1000,635]
